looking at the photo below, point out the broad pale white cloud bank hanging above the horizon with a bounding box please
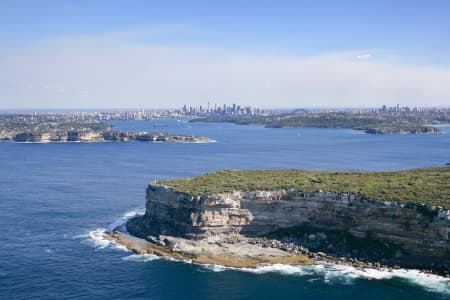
[0,34,450,108]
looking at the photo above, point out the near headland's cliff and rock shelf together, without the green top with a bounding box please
[114,185,450,277]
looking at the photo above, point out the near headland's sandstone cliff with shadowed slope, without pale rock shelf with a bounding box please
[127,168,450,274]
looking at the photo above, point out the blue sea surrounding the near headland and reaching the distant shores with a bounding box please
[0,120,450,299]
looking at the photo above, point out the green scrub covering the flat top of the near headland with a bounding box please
[157,166,450,209]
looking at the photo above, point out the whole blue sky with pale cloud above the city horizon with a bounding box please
[0,0,450,109]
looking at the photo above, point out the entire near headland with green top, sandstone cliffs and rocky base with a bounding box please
[109,166,450,276]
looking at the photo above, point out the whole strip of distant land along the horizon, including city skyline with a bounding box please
[0,103,450,142]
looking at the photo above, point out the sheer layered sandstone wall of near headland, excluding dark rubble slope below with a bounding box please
[132,185,450,266]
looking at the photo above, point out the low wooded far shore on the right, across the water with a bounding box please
[191,107,450,134]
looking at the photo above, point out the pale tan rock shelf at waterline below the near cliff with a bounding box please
[106,225,450,279]
